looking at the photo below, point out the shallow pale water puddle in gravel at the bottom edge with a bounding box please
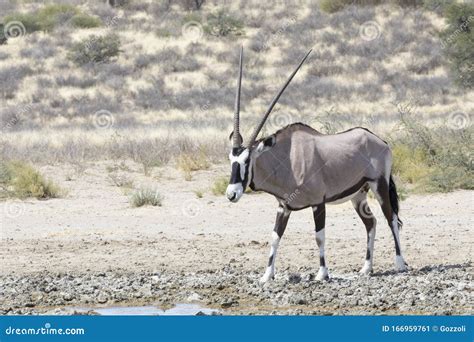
[74,304,219,316]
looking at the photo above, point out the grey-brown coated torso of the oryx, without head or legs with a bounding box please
[250,123,392,210]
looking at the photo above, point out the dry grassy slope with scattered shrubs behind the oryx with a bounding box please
[0,0,474,196]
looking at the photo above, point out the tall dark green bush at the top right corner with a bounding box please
[441,3,474,88]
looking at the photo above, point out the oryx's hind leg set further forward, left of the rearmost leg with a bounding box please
[352,186,377,274]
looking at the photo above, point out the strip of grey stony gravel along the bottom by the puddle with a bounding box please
[0,263,473,315]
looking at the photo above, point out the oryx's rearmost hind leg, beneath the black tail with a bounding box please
[370,177,407,271]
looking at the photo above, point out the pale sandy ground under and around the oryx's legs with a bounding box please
[0,163,474,314]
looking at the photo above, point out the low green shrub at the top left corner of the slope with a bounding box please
[3,4,101,33]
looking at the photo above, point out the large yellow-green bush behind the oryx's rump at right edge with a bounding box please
[392,114,474,192]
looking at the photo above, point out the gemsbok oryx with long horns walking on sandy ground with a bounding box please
[226,49,406,283]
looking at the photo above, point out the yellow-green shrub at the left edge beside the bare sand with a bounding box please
[0,162,62,199]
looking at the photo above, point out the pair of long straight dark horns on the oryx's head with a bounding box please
[233,47,312,148]
